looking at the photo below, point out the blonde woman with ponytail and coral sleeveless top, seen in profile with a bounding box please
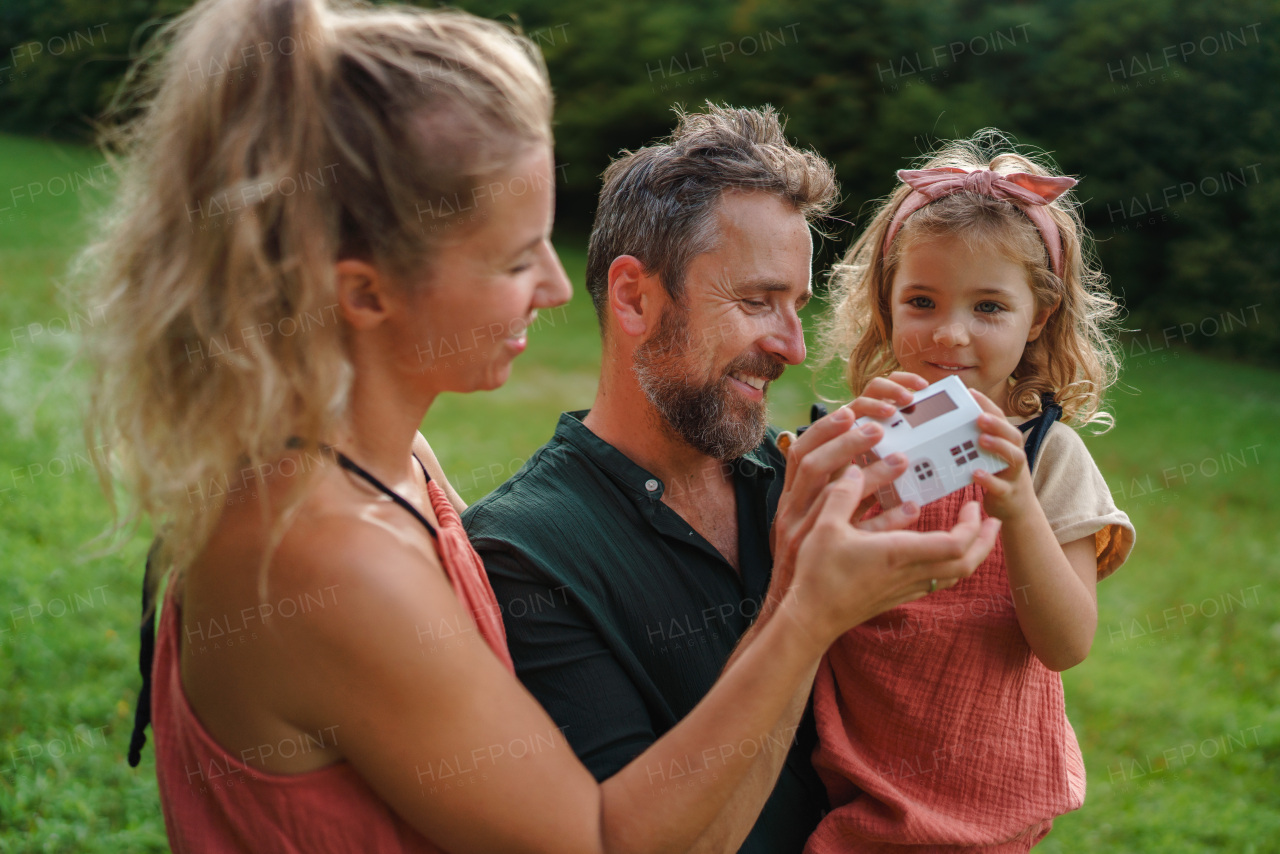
[88,0,995,851]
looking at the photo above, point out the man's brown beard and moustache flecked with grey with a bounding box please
[632,305,783,462]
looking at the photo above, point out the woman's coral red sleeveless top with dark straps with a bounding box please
[151,480,515,854]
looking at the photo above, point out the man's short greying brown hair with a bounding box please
[586,102,838,330]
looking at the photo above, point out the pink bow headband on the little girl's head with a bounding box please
[883,166,1078,277]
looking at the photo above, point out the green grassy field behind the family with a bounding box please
[0,130,1280,853]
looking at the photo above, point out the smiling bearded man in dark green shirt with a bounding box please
[463,106,986,854]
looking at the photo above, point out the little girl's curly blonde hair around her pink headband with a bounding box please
[819,128,1119,431]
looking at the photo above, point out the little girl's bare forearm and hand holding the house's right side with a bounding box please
[973,392,1098,671]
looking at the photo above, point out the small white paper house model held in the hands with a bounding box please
[858,376,1007,510]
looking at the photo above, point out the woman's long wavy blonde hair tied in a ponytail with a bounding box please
[78,0,552,589]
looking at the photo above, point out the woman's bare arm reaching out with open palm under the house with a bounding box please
[228,414,996,853]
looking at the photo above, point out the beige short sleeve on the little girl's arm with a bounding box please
[1032,423,1135,581]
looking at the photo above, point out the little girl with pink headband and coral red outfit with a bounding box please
[808,132,1134,854]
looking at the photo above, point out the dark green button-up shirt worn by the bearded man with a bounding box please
[462,411,826,854]
